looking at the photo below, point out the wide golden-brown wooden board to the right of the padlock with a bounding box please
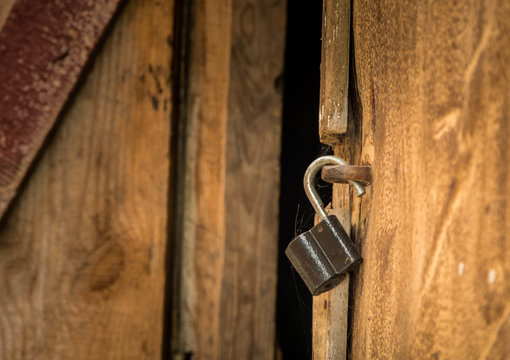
[352,0,510,359]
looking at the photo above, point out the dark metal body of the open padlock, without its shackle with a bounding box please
[285,215,361,295]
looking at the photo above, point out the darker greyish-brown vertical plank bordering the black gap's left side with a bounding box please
[219,0,286,359]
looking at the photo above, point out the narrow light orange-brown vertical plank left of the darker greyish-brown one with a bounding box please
[191,0,232,359]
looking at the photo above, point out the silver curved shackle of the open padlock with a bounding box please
[303,155,365,220]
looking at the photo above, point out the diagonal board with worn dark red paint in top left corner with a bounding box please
[0,0,119,217]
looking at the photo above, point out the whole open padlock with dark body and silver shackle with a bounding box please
[285,156,365,295]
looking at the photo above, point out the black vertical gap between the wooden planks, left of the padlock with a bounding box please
[276,1,331,360]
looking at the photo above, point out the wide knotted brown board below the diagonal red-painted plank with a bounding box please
[0,0,173,360]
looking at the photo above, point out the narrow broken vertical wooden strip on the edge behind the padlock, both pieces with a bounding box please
[312,0,353,360]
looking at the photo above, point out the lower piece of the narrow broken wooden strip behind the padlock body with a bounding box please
[312,208,351,360]
